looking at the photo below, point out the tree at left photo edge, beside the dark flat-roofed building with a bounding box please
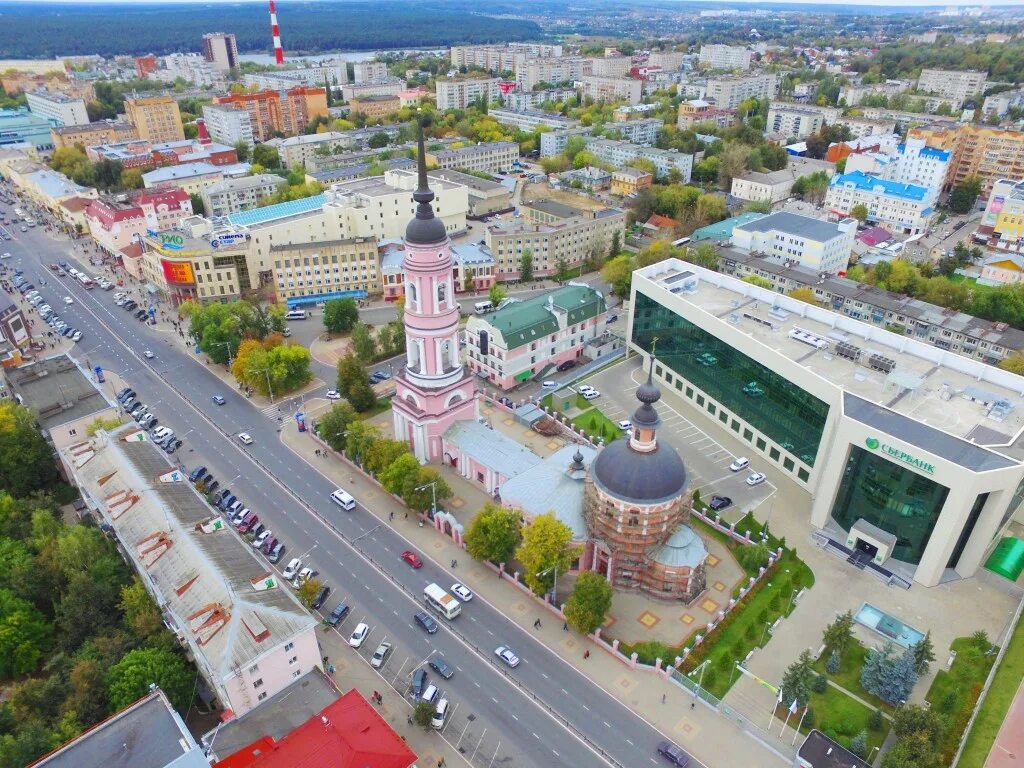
[0,399,57,497]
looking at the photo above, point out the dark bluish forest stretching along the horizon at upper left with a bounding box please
[0,0,543,58]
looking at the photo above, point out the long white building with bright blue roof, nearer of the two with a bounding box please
[825,171,938,234]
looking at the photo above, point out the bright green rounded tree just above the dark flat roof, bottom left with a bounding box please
[106,648,192,712]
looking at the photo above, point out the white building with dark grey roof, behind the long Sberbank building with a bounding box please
[732,211,857,274]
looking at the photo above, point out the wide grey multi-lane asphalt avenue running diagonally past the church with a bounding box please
[12,227,699,768]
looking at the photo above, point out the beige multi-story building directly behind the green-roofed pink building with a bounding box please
[484,200,626,281]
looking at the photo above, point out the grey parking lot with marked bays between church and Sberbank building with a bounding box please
[586,357,775,522]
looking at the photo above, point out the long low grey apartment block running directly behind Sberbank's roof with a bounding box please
[719,249,1024,365]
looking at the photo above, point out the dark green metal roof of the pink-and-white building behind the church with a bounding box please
[486,286,607,349]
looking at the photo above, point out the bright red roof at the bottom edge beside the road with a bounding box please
[215,688,416,768]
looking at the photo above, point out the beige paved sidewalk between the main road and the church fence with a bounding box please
[282,423,781,768]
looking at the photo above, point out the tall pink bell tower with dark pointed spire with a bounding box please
[391,124,477,463]
